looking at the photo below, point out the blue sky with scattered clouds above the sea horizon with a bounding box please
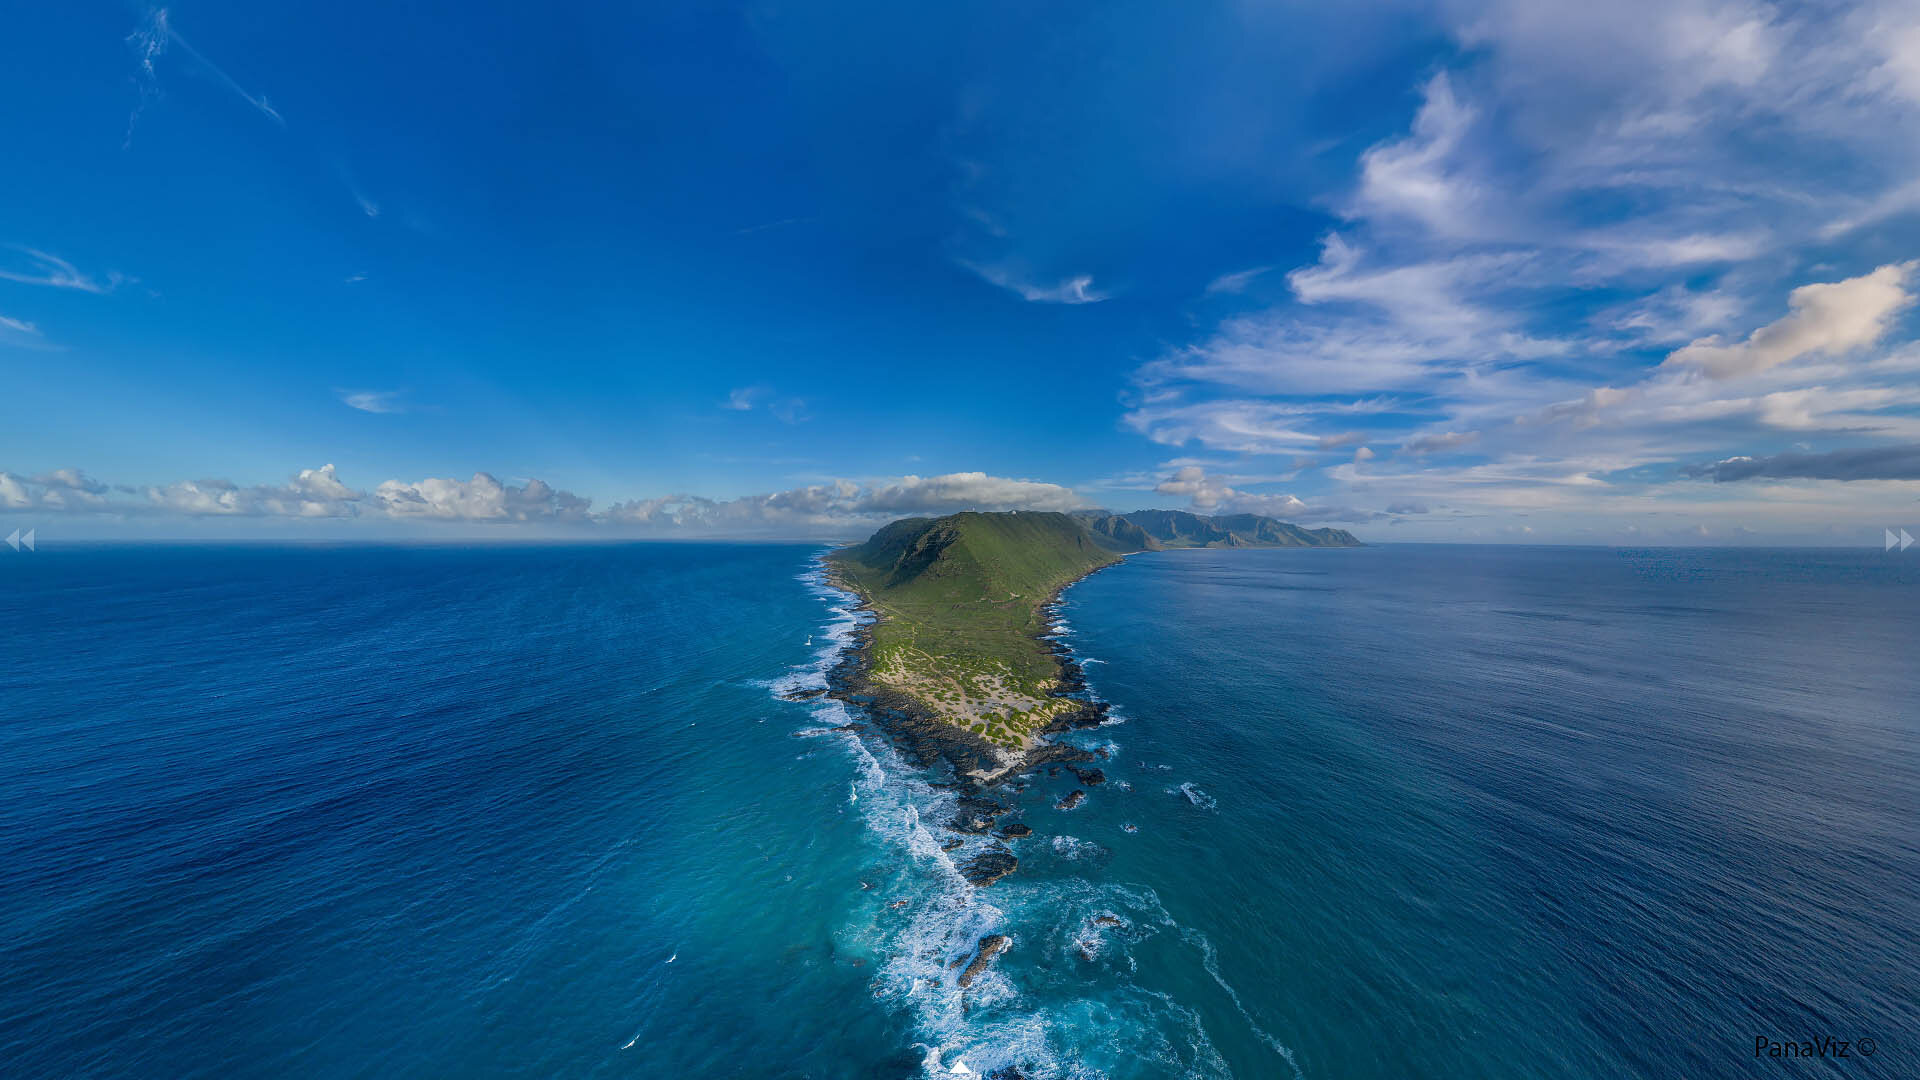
[0,0,1920,546]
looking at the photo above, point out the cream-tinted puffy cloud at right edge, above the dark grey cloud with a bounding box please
[1667,263,1914,379]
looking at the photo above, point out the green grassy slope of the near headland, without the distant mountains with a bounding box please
[828,513,1133,748]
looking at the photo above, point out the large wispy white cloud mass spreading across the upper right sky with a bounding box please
[1125,0,1920,534]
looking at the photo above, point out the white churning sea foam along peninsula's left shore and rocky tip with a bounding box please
[770,553,1229,1080]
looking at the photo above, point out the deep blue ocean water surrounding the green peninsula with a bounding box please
[0,544,1920,1080]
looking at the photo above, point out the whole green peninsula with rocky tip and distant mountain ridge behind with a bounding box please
[828,509,1359,778]
